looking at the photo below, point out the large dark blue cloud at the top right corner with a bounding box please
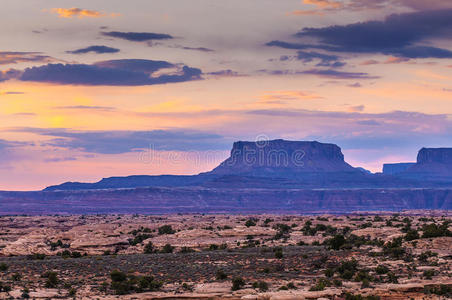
[294,9,452,58]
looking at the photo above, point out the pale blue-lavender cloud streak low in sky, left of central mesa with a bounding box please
[32,129,230,154]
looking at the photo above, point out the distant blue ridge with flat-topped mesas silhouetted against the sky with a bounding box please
[44,139,452,191]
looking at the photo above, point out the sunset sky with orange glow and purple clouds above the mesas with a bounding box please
[0,0,452,190]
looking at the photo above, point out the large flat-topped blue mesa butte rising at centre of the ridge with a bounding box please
[211,140,358,176]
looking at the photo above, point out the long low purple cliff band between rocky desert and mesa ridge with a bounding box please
[0,188,452,215]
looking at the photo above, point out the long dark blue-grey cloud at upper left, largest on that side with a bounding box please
[8,59,202,86]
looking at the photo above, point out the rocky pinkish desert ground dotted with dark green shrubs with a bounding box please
[0,211,452,300]
